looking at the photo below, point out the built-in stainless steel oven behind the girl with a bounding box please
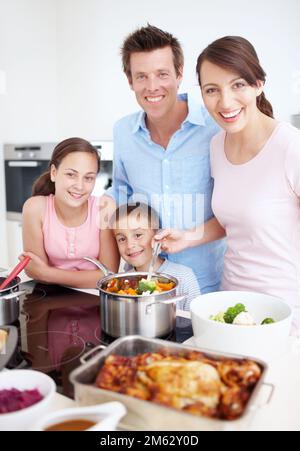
[4,143,55,220]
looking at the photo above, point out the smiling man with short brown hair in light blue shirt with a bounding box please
[107,25,224,293]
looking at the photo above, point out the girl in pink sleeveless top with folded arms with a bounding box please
[23,138,119,288]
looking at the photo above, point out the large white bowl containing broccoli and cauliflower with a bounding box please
[191,291,292,361]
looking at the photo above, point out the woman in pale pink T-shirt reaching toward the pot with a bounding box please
[156,36,300,329]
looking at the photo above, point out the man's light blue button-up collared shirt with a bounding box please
[107,94,225,293]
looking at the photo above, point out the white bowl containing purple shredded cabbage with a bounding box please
[0,370,56,431]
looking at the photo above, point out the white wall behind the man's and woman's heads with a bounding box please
[57,0,300,139]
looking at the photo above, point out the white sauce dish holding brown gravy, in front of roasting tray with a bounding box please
[34,401,126,431]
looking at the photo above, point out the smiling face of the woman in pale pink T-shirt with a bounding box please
[200,60,263,133]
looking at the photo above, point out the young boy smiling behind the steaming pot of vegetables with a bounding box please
[111,203,200,310]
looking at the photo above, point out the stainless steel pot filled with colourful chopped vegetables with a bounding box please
[86,258,186,338]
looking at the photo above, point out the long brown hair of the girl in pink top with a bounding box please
[32,138,100,196]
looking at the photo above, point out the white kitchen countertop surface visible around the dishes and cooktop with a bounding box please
[9,276,300,431]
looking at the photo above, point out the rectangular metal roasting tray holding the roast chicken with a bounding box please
[70,335,274,431]
